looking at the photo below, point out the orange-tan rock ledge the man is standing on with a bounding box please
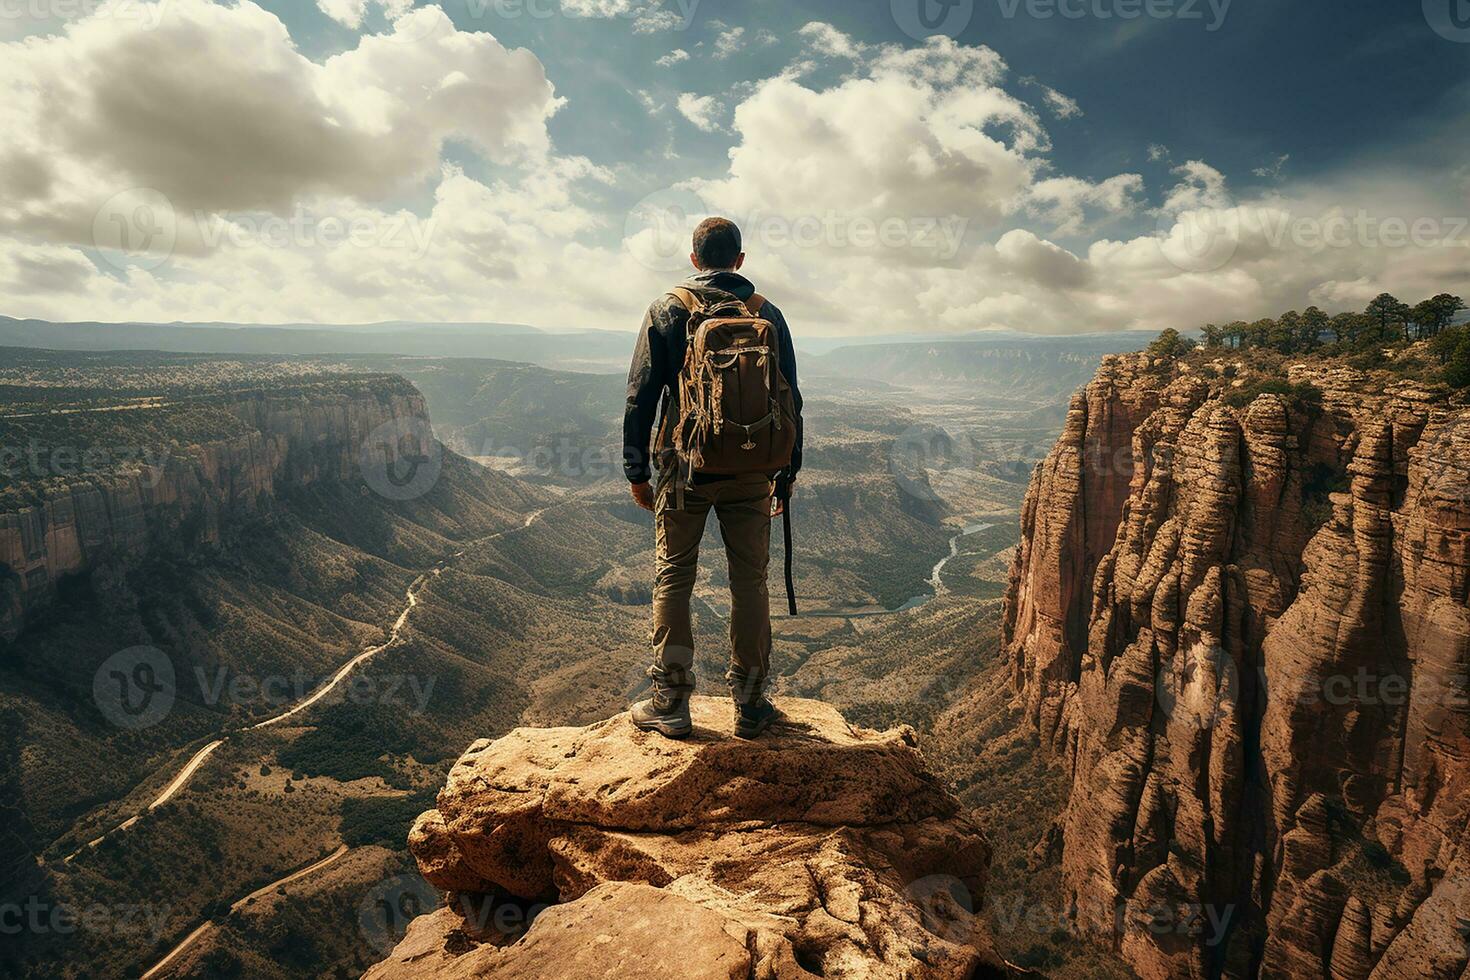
[368,698,1007,980]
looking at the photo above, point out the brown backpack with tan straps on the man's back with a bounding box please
[657,287,797,482]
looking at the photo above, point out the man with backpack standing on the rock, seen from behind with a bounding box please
[623,217,801,739]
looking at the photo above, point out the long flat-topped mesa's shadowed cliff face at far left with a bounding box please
[0,378,429,642]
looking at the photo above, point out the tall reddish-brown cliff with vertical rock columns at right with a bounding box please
[1004,356,1470,979]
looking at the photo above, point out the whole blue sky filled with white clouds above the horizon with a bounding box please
[0,0,1470,336]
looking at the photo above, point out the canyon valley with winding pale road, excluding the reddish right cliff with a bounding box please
[0,351,1057,977]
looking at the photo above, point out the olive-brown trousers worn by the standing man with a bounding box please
[648,473,775,704]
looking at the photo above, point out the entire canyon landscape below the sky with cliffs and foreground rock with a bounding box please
[14,333,1470,979]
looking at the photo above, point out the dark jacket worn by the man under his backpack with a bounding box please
[623,272,803,483]
